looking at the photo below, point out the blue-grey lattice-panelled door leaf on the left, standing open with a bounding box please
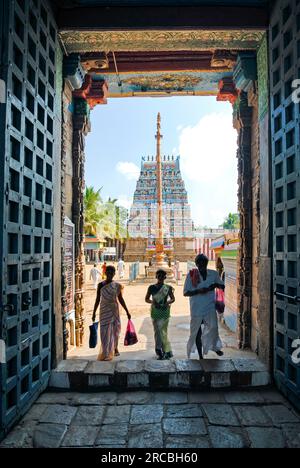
[0,0,57,435]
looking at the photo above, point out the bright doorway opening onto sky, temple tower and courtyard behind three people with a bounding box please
[68,92,255,361]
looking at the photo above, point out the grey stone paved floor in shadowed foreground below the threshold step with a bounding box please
[0,390,300,449]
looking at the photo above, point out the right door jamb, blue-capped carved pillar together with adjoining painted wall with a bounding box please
[234,44,272,364]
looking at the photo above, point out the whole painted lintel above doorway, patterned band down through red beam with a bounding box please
[60,10,264,99]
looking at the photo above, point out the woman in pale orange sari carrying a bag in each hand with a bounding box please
[92,266,131,361]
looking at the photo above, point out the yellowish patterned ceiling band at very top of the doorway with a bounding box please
[60,30,264,54]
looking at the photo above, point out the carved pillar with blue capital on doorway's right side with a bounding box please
[233,52,259,351]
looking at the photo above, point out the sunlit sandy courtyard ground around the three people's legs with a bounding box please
[68,263,255,360]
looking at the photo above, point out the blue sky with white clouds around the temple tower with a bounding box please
[86,96,238,228]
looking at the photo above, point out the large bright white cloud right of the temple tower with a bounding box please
[179,113,237,227]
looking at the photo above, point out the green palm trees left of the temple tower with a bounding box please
[84,187,127,239]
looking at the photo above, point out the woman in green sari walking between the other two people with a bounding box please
[145,270,175,359]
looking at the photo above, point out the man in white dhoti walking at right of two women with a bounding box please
[183,255,225,359]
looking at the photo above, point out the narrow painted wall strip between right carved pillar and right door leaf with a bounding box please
[234,36,272,364]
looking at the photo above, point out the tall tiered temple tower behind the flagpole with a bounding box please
[125,156,195,262]
